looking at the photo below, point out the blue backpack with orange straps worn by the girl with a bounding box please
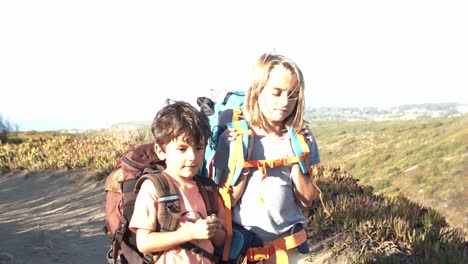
[197,91,331,263]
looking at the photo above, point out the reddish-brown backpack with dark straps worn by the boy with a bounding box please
[105,143,218,263]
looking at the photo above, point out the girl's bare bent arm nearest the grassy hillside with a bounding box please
[291,163,318,208]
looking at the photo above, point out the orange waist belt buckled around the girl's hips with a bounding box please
[246,229,307,263]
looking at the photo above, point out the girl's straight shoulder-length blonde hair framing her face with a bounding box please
[244,54,305,133]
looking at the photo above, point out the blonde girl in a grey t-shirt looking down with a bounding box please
[214,54,320,263]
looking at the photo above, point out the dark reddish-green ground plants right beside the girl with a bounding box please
[308,165,468,263]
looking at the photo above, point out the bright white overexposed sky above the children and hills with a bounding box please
[0,0,468,131]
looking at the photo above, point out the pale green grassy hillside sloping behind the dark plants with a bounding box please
[310,116,468,232]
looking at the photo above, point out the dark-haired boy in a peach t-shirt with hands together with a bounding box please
[129,102,226,263]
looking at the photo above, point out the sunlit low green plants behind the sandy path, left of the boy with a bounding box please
[0,129,148,179]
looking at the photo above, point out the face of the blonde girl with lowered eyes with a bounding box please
[258,65,298,125]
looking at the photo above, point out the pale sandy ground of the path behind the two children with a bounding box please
[0,170,336,264]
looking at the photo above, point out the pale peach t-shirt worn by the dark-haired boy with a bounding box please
[129,174,225,263]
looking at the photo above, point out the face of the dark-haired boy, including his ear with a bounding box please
[156,136,205,178]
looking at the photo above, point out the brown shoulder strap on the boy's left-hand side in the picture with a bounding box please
[135,172,181,232]
